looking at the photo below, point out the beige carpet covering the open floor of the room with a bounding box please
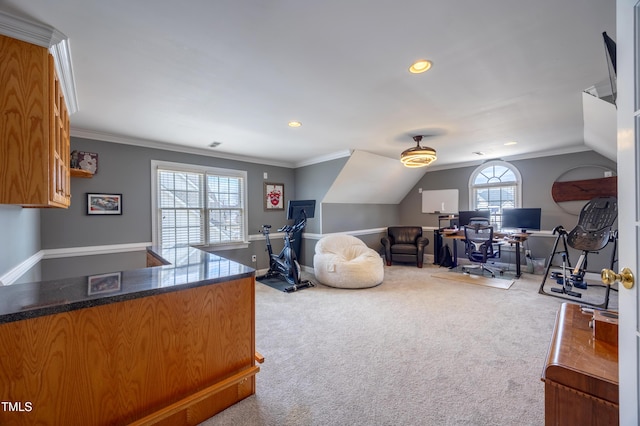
[202,264,604,426]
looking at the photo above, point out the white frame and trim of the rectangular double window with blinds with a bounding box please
[151,160,249,250]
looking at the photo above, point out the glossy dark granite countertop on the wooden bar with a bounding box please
[0,247,255,324]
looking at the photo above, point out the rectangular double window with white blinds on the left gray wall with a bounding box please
[155,163,247,247]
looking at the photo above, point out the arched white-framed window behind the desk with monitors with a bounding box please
[469,160,522,229]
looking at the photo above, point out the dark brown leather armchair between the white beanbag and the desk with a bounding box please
[380,226,429,268]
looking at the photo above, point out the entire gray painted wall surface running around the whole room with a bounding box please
[0,142,616,280]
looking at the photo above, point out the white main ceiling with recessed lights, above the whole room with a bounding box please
[0,0,615,167]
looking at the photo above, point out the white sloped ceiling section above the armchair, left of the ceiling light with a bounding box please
[322,151,426,204]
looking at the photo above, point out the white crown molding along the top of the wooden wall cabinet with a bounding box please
[0,11,78,115]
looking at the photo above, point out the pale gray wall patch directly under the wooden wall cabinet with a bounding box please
[0,204,40,275]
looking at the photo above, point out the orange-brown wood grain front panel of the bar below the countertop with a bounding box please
[0,277,258,425]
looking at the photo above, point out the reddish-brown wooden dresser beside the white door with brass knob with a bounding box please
[542,303,619,426]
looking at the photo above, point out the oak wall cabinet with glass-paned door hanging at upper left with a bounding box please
[0,36,71,208]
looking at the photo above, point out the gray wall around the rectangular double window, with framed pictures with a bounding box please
[41,138,296,268]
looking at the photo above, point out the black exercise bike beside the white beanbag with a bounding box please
[256,212,314,293]
